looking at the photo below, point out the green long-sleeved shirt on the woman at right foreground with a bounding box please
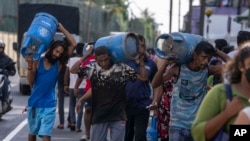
[191,84,250,141]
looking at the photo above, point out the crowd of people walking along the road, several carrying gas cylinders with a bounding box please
[12,20,250,141]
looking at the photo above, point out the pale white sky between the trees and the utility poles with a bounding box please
[129,0,189,33]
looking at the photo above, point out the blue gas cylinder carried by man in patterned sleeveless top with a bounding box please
[154,32,205,64]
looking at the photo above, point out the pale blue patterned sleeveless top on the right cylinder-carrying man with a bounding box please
[170,64,208,129]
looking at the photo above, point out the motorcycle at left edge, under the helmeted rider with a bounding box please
[0,62,15,118]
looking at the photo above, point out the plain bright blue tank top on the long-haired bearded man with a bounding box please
[28,58,58,108]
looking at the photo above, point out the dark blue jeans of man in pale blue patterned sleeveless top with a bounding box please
[169,126,194,141]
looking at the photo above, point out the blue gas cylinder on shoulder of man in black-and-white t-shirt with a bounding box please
[94,33,139,62]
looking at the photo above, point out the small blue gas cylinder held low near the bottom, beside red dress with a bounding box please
[147,116,158,141]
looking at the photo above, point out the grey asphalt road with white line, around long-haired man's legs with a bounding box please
[0,75,85,141]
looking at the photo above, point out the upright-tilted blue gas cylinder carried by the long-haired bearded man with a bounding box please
[21,12,58,60]
